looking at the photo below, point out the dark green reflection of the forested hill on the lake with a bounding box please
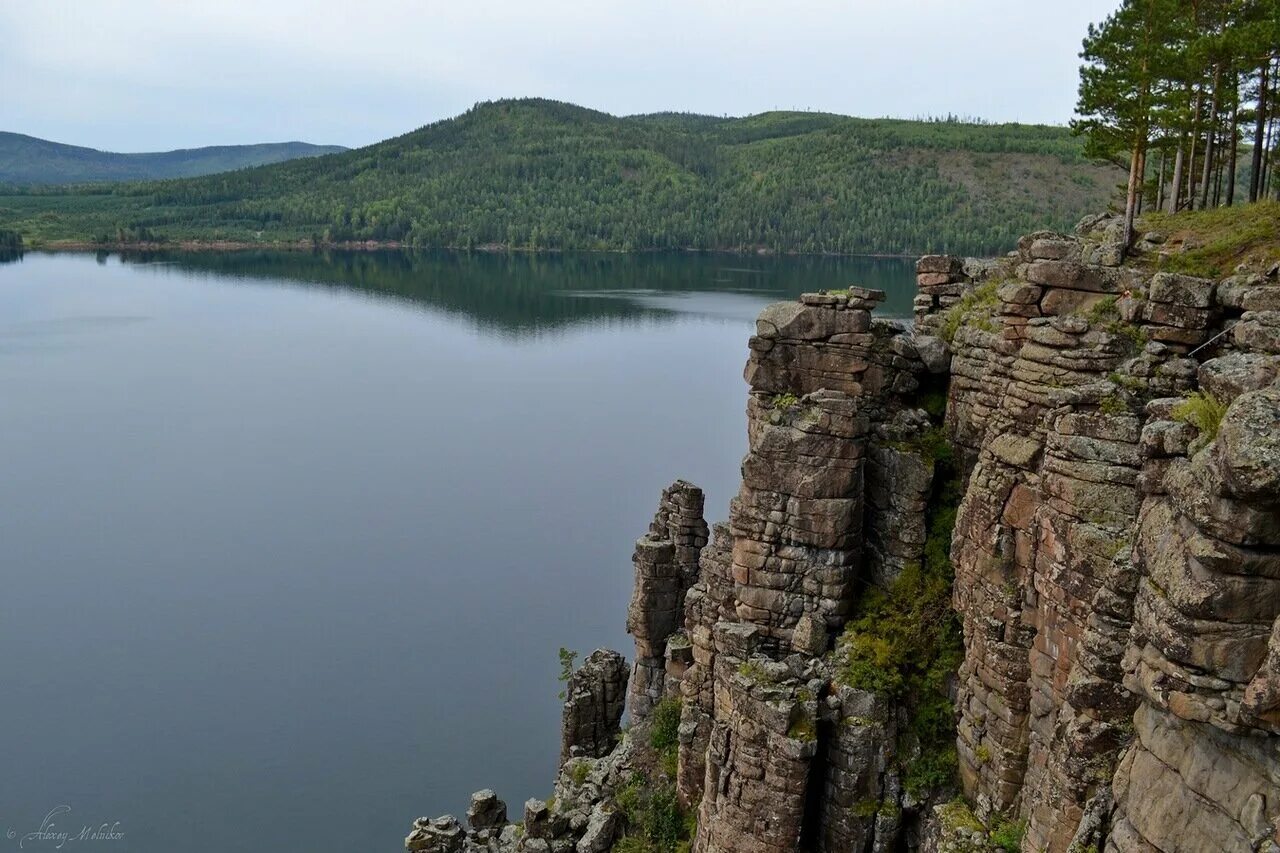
[107,251,914,337]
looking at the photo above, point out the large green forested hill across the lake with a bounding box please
[0,100,1119,254]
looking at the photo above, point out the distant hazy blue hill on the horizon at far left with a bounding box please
[0,131,347,184]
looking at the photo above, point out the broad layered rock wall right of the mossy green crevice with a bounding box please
[918,213,1280,852]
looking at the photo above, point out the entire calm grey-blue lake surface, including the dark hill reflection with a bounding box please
[0,254,913,853]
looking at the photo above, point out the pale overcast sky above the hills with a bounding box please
[0,0,1119,151]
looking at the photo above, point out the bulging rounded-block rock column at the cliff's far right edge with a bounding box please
[1106,386,1280,850]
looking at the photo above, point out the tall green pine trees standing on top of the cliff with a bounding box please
[1073,0,1280,243]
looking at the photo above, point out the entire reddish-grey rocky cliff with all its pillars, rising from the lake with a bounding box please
[407,212,1280,853]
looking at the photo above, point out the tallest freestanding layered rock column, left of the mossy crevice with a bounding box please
[678,288,933,853]
